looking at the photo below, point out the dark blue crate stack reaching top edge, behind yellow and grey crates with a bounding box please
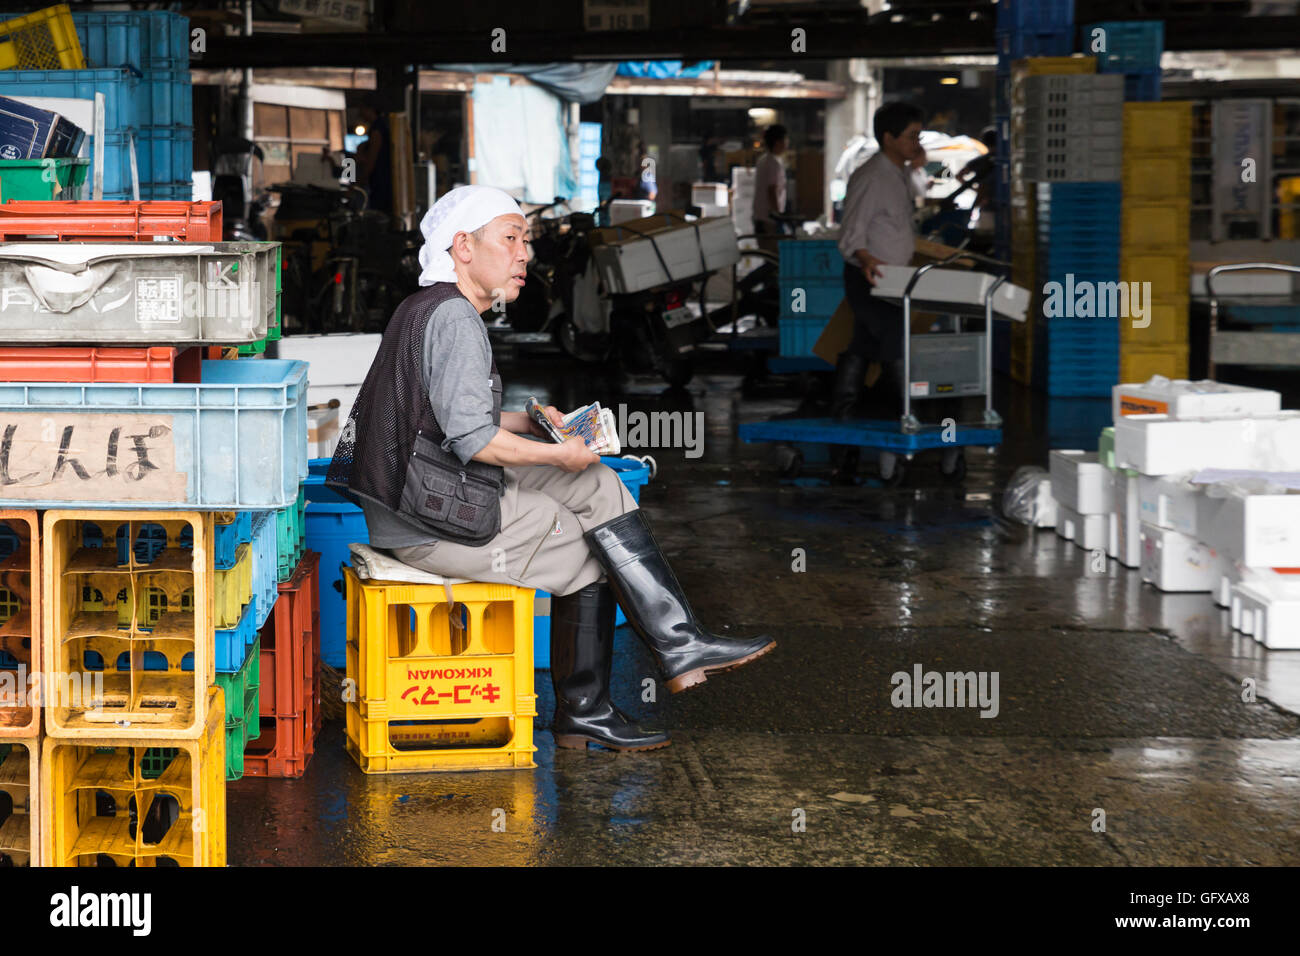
[993,0,1074,261]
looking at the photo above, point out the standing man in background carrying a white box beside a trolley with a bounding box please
[831,103,926,419]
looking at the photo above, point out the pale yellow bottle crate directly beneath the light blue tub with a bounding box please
[42,510,216,740]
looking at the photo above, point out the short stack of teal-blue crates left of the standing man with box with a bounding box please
[777,239,844,358]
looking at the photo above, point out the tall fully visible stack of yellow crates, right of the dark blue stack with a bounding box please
[1119,101,1192,382]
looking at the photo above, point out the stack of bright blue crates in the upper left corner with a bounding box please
[71,12,194,200]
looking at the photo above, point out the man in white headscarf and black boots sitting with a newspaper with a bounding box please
[326,186,775,750]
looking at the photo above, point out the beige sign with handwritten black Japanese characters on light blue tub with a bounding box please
[0,411,187,503]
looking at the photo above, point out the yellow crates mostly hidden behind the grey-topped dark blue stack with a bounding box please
[998,56,1097,385]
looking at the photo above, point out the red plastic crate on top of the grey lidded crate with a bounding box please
[0,199,221,242]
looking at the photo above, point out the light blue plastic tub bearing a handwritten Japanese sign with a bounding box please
[0,359,307,511]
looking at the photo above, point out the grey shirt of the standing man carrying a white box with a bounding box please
[840,152,917,265]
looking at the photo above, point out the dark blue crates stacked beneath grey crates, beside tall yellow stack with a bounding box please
[1034,182,1121,398]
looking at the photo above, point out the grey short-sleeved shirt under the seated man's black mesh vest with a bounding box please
[361,295,497,549]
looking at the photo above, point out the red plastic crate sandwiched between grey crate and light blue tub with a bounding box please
[0,348,205,382]
